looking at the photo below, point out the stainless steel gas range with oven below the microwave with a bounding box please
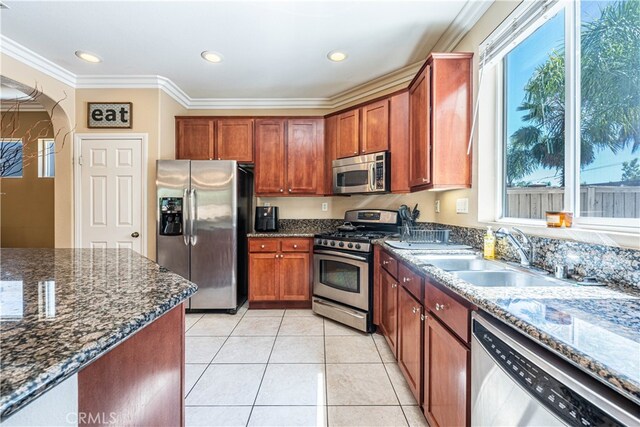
[312,209,399,332]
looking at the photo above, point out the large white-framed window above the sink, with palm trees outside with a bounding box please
[490,0,640,227]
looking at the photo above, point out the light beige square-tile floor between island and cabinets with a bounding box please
[185,307,427,427]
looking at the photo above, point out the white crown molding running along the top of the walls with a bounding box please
[0,0,493,110]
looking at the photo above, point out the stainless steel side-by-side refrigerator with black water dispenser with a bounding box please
[156,160,253,313]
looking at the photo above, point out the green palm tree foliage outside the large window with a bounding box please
[507,0,640,185]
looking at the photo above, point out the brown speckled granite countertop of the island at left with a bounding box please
[0,249,197,419]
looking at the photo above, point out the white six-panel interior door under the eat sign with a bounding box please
[76,138,145,253]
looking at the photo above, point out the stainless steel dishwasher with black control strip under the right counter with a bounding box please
[471,313,640,427]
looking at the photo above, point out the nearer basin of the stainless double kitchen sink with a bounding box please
[452,271,570,288]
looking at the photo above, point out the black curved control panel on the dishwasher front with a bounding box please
[473,321,623,427]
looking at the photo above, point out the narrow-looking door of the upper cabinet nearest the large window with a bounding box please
[409,65,431,187]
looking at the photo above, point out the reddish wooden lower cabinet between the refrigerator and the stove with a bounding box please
[249,239,311,308]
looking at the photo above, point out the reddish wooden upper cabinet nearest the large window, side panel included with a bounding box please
[409,53,473,190]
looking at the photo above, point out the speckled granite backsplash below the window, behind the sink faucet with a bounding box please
[421,223,640,289]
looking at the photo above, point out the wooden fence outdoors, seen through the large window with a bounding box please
[505,186,640,219]
